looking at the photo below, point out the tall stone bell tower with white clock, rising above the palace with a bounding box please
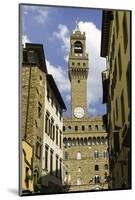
[68,24,88,119]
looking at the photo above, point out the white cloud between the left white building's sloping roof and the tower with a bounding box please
[46,60,70,96]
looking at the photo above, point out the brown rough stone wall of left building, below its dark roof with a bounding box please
[21,65,45,177]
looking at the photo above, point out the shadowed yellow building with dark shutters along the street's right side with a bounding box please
[101,10,131,189]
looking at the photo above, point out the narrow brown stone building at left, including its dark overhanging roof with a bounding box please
[21,44,47,191]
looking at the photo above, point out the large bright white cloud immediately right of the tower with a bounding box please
[79,22,105,108]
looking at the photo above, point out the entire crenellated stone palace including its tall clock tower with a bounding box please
[63,25,109,192]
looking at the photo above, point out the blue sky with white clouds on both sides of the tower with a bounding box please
[21,5,105,116]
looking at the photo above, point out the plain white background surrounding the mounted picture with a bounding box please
[0,0,135,200]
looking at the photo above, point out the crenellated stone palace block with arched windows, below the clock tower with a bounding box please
[63,117,109,191]
